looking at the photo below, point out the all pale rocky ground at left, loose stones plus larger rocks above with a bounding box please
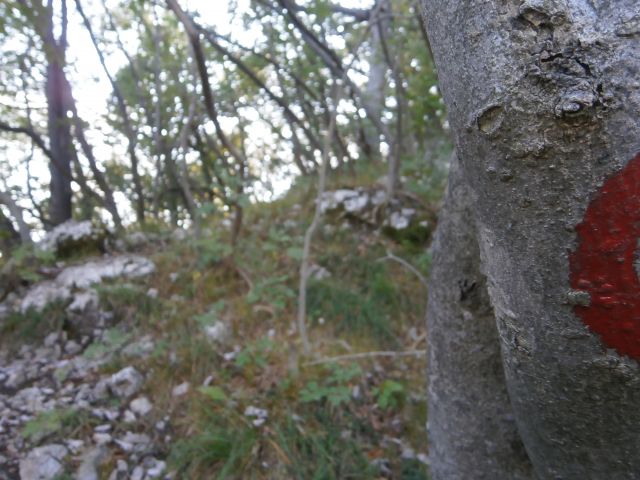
[0,222,172,480]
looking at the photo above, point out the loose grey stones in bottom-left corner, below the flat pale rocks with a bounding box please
[0,332,171,480]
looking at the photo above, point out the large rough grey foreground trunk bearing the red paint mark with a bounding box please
[423,0,640,480]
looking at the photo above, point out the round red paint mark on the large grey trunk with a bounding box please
[569,154,640,360]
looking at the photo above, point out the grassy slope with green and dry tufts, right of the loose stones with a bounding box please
[5,157,437,480]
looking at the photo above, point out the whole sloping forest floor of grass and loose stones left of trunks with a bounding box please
[0,160,442,480]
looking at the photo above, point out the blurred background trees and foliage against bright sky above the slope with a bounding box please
[0,0,447,244]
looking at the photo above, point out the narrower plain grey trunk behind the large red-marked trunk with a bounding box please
[427,155,534,480]
